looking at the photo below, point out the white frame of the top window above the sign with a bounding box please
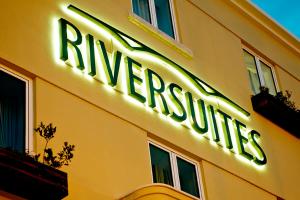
[131,0,179,41]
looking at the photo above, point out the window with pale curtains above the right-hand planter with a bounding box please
[244,50,278,95]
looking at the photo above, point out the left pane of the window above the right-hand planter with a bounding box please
[244,50,260,94]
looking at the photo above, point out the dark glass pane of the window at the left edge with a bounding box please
[0,70,26,152]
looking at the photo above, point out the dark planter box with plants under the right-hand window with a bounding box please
[251,87,300,138]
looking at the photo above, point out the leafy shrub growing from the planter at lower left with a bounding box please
[32,122,75,168]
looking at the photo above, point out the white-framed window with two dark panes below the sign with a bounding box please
[150,143,200,198]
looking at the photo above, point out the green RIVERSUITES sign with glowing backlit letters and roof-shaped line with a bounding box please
[58,5,267,166]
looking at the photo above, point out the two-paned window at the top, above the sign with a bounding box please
[132,0,177,39]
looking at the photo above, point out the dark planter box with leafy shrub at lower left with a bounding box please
[0,123,75,200]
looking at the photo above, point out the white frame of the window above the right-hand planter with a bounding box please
[243,47,280,92]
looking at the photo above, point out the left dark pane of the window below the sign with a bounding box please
[150,144,173,186]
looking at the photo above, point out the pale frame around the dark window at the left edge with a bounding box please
[0,64,33,153]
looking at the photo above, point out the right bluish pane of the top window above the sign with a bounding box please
[154,0,174,38]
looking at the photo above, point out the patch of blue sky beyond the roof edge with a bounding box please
[251,0,300,39]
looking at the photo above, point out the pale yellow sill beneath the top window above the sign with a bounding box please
[128,12,193,59]
